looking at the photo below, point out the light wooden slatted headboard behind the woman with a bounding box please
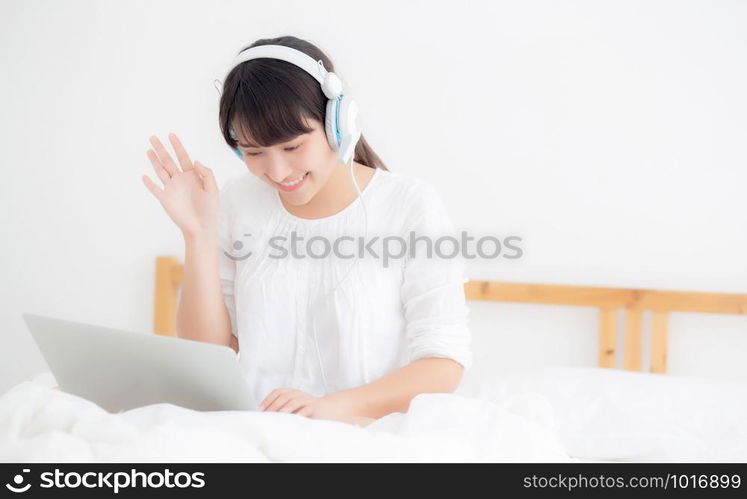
[153,256,747,373]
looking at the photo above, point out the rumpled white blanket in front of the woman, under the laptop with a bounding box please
[0,373,576,462]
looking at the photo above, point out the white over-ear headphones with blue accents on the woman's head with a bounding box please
[215,45,361,163]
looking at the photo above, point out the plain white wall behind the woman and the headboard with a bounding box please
[0,0,747,391]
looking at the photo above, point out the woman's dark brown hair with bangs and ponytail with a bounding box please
[219,36,388,170]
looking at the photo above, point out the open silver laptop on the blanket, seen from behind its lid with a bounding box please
[23,313,259,412]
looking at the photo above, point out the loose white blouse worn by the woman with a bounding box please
[219,169,472,410]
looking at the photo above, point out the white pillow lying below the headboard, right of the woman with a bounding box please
[457,367,747,462]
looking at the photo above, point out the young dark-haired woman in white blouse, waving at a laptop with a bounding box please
[143,36,472,424]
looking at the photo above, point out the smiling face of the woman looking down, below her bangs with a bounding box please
[235,120,337,206]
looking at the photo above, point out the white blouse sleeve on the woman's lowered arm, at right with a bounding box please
[401,183,472,369]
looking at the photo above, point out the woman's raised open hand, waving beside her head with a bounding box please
[143,133,219,237]
